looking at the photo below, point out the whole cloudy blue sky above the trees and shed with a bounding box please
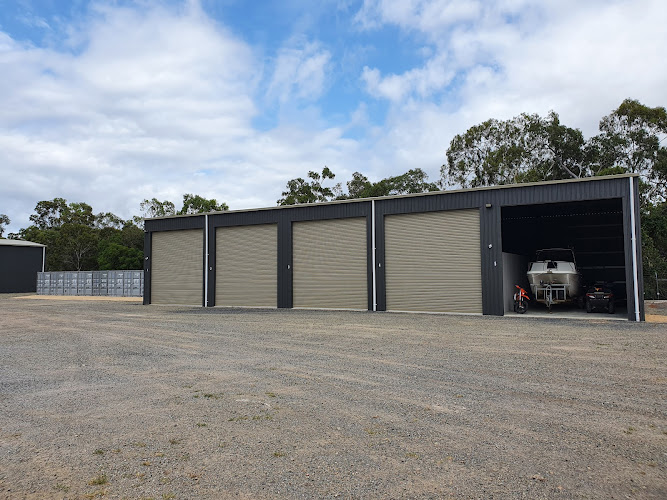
[0,0,667,235]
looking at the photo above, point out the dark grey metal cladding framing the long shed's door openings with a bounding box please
[145,176,644,319]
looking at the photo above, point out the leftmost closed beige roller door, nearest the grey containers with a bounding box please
[151,229,204,306]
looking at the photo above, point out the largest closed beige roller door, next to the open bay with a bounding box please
[385,209,482,313]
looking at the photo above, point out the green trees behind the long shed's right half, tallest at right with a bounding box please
[278,99,667,299]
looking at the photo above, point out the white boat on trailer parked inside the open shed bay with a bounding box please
[527,248,581,307]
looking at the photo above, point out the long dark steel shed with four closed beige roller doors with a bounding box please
[144,174,644,321]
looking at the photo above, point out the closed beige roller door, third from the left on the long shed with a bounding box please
[292,217,368,309]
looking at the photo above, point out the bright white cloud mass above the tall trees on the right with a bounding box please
[357,0,667,186]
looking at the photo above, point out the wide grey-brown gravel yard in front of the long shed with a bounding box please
[0,296,667,499]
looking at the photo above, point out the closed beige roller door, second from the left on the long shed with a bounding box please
[215,224,278,307]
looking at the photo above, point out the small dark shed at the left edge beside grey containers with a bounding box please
[0,239,46,293]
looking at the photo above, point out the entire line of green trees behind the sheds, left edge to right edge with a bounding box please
[0,99,667,298]
